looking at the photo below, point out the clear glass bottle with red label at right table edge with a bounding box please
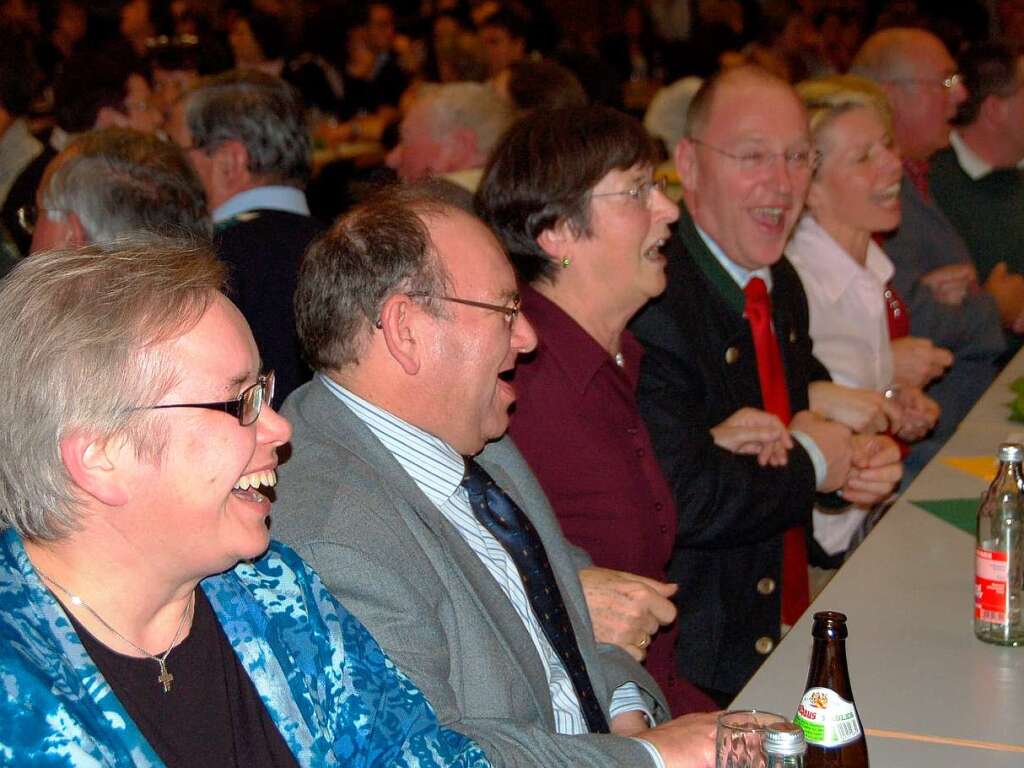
[974,442,1024,645]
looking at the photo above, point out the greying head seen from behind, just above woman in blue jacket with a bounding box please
[24,128,211,253]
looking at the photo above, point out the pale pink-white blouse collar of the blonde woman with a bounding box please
[786,213,894,303]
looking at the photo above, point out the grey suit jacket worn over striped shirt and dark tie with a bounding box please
[272,379,667,768]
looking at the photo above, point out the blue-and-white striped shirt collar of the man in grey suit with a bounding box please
[316,374,466,508]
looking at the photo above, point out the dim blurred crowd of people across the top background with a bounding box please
[0,0,1024,237]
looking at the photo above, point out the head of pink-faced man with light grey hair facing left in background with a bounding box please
[387,83,515,191]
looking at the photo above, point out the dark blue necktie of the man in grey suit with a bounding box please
[462,459,608,733]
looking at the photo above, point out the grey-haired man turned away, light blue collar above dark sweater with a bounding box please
[168,70,323,401]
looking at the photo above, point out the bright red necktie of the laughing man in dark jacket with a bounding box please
[743,278,811,627]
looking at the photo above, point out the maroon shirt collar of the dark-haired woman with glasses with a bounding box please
[519,285,643,392]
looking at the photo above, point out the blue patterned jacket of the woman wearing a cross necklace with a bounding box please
[0,529,488,768]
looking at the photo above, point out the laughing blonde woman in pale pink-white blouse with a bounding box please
[785,76,944,552]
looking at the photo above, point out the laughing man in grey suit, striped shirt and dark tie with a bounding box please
[273,187,714,768]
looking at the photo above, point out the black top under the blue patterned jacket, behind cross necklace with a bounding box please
[66,589,298,768]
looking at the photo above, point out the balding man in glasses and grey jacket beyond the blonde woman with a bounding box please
[850,28,1007,476]
